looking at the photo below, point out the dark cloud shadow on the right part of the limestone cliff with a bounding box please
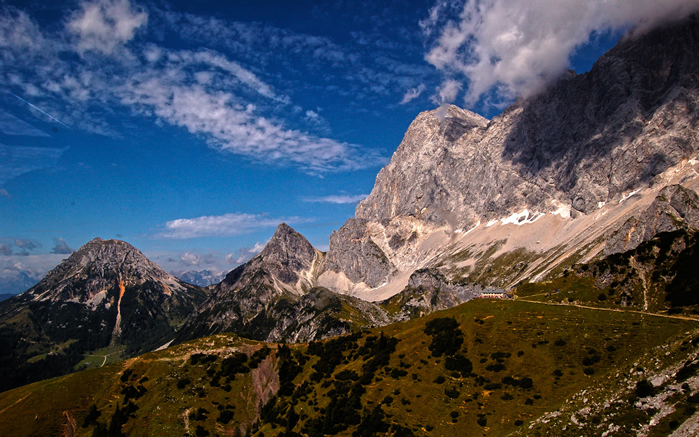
[503,16,699,212]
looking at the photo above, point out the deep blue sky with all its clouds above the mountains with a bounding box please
[0,0,695,281]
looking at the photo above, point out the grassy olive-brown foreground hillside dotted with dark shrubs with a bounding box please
[0,300,699,436]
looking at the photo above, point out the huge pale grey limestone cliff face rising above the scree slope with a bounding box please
[320,17,699,292]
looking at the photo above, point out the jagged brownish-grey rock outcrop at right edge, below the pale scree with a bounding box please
[604,185,699,255]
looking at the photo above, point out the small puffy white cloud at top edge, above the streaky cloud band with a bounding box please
[67,0,148,54]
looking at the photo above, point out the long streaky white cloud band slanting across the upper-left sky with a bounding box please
[0,0,385,174]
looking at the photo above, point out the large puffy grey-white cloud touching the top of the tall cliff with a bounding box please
[421,0,699,105]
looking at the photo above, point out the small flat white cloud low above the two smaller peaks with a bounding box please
[156,214,313,239]
